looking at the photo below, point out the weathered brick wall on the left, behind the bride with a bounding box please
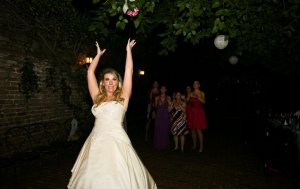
[0,37,90,152]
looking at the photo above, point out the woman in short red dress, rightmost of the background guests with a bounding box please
[187,81,207,152]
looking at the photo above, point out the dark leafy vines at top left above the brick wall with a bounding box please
[6,0,93,63]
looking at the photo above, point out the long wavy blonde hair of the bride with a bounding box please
[94,68,124,106]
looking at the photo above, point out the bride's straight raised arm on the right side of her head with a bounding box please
[122,39,136,102]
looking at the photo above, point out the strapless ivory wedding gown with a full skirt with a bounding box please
[68,101,157,189]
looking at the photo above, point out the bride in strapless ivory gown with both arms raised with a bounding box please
[68,39,157,189]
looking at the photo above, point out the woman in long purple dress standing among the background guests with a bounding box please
[153,86,171,150]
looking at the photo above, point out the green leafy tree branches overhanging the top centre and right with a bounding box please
[90,0,300,71]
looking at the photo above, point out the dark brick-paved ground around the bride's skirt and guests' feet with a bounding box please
[0,119,294,189]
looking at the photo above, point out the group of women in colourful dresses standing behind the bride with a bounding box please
[145,80,207,152]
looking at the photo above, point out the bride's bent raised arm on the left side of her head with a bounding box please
[87,42,106,101]
